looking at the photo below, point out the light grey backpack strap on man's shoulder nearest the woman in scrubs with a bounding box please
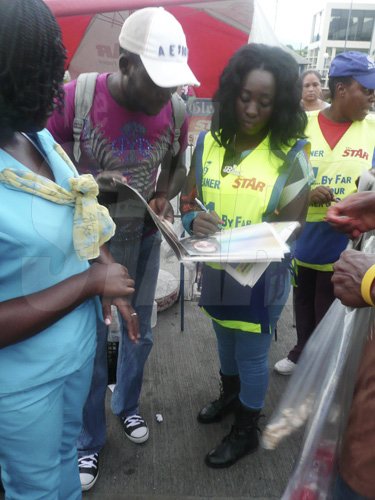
[73,73,99,163]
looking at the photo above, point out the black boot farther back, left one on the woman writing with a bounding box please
[197,372,240,424]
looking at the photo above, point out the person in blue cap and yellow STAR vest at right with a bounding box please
[274,51,375,375]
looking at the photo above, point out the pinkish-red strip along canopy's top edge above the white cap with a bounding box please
[44,0,216,17]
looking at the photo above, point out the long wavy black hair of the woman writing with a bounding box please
[211,43,307,156]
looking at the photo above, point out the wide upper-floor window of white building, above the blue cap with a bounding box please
[328,9,375,42]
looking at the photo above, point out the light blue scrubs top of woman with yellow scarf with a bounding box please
[0,130,96,395]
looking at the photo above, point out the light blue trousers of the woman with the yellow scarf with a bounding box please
[0,358,93,500]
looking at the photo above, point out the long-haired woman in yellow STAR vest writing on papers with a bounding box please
[181,44,312,468]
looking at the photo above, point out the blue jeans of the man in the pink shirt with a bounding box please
[78,232,161,456]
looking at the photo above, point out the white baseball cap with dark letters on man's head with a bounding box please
[119,7,200,88]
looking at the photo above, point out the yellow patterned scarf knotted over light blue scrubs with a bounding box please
[0,168,116,260]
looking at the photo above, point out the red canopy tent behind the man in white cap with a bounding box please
[45,0,254,97]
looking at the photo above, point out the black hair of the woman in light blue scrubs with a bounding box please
[0,0,66,141]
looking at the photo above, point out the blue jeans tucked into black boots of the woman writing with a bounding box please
[212,321,272,410]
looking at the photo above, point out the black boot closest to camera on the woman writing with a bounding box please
[205,403,260,469]
